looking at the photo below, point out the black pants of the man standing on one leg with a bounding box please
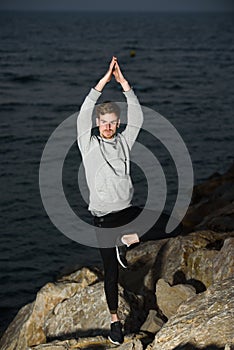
[94,206,183,314]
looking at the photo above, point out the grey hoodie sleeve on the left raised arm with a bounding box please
[77,88,101,154]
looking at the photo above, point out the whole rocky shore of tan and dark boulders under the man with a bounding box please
[0,165,234,350]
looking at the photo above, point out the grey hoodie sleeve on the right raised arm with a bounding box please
[122,89,144,150]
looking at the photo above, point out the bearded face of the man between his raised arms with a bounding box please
[96,113,120,139]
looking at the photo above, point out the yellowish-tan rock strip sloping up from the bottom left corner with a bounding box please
[0,269,98,350]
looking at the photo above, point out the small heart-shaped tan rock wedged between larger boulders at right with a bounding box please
[156,279,196,318]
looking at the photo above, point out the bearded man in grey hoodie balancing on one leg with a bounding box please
[77,56,183,345]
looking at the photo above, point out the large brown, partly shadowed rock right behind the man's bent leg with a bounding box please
[120,231,234,304]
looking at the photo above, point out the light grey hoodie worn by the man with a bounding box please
[77,89,143,216]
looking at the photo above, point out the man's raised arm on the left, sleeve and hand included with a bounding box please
[77,56,116,154]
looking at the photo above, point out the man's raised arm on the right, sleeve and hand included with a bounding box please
[113,61,143,149]
